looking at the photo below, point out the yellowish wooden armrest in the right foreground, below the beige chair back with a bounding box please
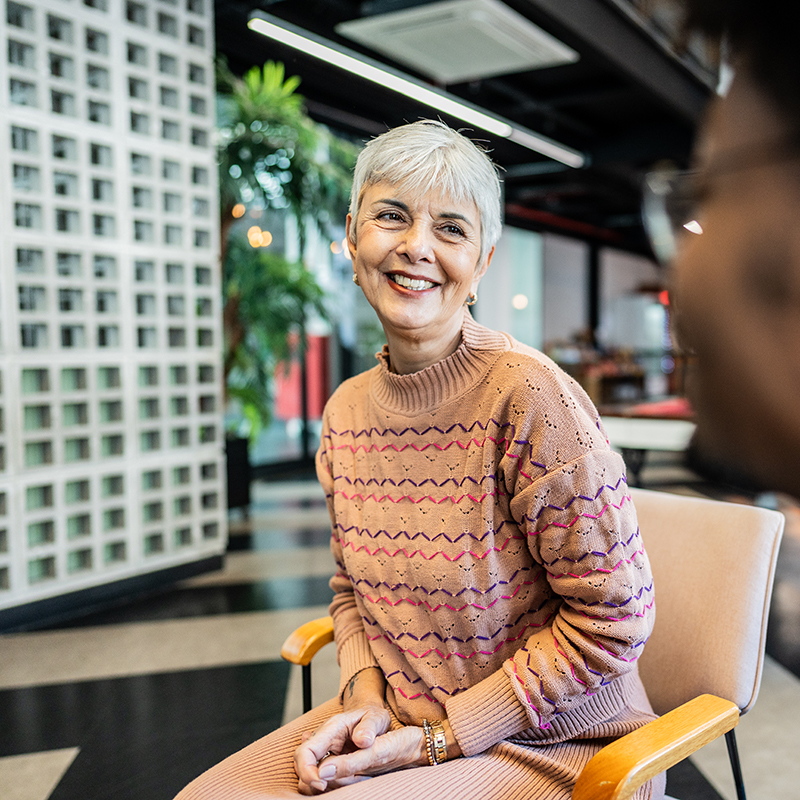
[572,694,739,800]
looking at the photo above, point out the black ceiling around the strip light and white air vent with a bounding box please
[216,0,715,253]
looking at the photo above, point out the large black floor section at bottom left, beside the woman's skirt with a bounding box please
[0,662,289,800]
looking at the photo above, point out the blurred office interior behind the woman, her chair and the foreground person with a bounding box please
[0,0,800,800]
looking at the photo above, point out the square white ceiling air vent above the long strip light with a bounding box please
[336,0,578,84]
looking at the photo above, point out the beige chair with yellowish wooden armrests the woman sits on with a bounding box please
[281,489,784,800]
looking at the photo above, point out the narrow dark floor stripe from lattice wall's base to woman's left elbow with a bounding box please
[44,576,333,629]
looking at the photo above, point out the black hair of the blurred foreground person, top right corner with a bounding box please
[682,0,800,137]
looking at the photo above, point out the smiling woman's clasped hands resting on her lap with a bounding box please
[294,706,428,795]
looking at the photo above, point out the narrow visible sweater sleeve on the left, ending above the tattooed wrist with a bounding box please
[316,418,378,694]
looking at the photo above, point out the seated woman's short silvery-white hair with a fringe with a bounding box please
[350,120,502,260]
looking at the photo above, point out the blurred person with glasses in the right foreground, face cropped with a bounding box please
[645,0,800,497]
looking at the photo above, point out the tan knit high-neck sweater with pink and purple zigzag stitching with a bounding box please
[317,313,655,755]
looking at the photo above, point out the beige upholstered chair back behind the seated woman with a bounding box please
[631,489,784,714]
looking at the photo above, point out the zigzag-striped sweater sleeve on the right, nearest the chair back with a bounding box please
[447,409,655,755]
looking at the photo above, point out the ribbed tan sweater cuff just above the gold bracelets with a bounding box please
[446,669,531,756]
